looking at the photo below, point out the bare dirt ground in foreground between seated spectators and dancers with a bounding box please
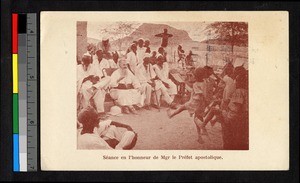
[110,108,222,150]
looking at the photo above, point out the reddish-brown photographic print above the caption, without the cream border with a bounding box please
[74,21,249,150]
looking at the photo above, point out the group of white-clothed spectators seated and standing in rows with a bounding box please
[77,38,177,114]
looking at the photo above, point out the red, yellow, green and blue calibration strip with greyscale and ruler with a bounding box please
[12,13,37,172]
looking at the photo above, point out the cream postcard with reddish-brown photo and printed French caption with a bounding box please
[40,11,289,171]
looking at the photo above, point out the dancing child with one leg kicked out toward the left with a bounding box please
[167,68,205,143]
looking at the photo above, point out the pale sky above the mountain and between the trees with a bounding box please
[87,22,212,41]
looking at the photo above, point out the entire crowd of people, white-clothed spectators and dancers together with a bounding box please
[77,32,248,149]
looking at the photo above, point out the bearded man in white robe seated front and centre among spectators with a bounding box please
[110,58,142,114]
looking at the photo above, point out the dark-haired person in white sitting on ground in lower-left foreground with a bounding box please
[77,108,137,149]
